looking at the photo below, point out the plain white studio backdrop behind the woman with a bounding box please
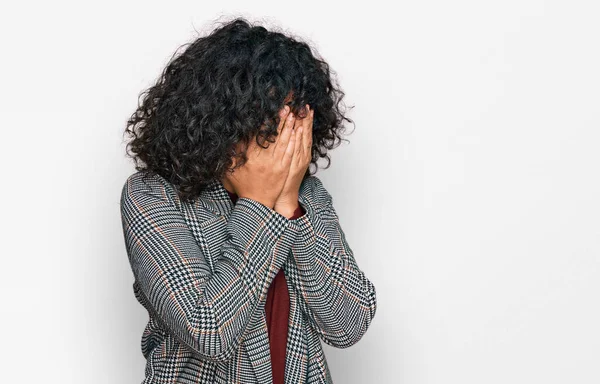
[0,0,600,384]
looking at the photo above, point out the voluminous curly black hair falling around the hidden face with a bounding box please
[124,17,354,201]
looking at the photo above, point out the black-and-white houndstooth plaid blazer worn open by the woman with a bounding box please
[121,171,377,384]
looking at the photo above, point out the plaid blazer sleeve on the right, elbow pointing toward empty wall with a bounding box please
[289,176,377,348]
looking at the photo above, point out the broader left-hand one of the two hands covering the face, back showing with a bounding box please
[224,106,296,208]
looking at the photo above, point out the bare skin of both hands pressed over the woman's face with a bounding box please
[221,104,314,217]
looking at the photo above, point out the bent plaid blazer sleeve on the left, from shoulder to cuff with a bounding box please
[121,176,297,361]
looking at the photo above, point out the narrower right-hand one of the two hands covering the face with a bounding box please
[274,104,314,216]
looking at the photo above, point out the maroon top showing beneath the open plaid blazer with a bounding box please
[227,191,306,384]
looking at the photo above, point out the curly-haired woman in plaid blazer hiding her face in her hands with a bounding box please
[121,19,376,384]
